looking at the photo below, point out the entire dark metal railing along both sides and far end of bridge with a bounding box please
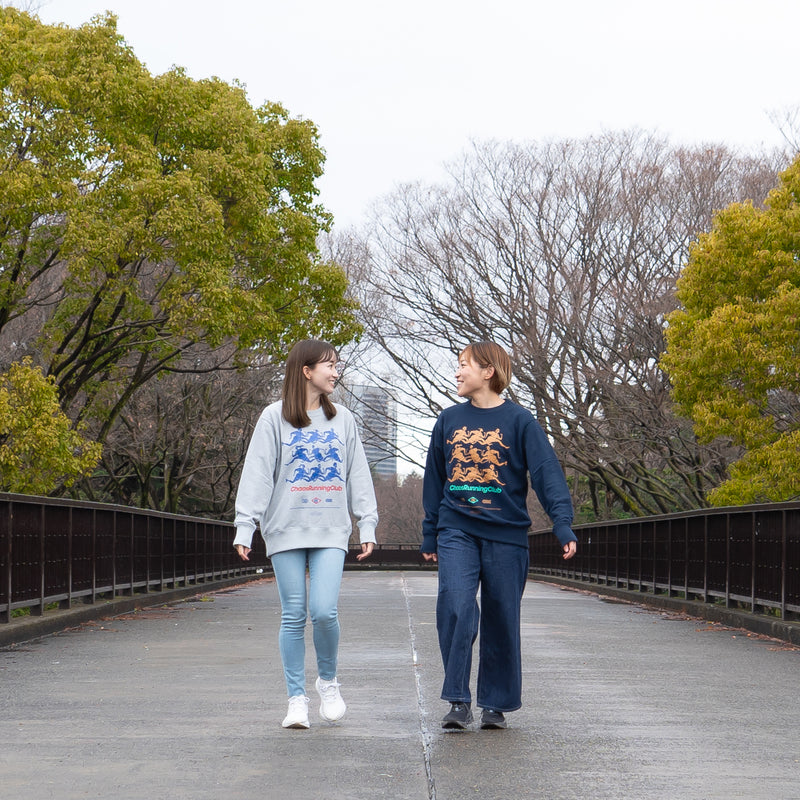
[7,494,800,623]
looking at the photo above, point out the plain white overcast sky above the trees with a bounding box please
[29,0,800,231]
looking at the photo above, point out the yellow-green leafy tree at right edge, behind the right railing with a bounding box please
[663,157,800,505]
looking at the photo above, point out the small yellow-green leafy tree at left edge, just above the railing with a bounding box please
[0,359,101,494]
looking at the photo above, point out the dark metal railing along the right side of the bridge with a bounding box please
[530,503,800,620]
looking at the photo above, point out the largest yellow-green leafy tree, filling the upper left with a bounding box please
[0,7,359,441]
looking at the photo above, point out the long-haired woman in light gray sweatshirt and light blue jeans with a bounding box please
[233,339,378,728]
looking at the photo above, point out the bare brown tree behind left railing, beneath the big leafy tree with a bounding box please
[77,357,280,518]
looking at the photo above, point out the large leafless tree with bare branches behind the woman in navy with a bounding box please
[335,131,785,516]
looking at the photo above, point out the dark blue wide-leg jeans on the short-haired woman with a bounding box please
[436,528,528,711]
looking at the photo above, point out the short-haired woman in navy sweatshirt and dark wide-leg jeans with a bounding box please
[420,342,577,729]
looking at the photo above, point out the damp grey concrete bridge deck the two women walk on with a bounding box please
[0,572,800,800]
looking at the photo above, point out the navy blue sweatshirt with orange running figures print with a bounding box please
[420,400,577,553]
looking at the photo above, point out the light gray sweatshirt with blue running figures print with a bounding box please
[233,401,378,555]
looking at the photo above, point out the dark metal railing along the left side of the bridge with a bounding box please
[0,494,267,623]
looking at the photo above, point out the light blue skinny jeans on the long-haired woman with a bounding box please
[270,547,345,697]
